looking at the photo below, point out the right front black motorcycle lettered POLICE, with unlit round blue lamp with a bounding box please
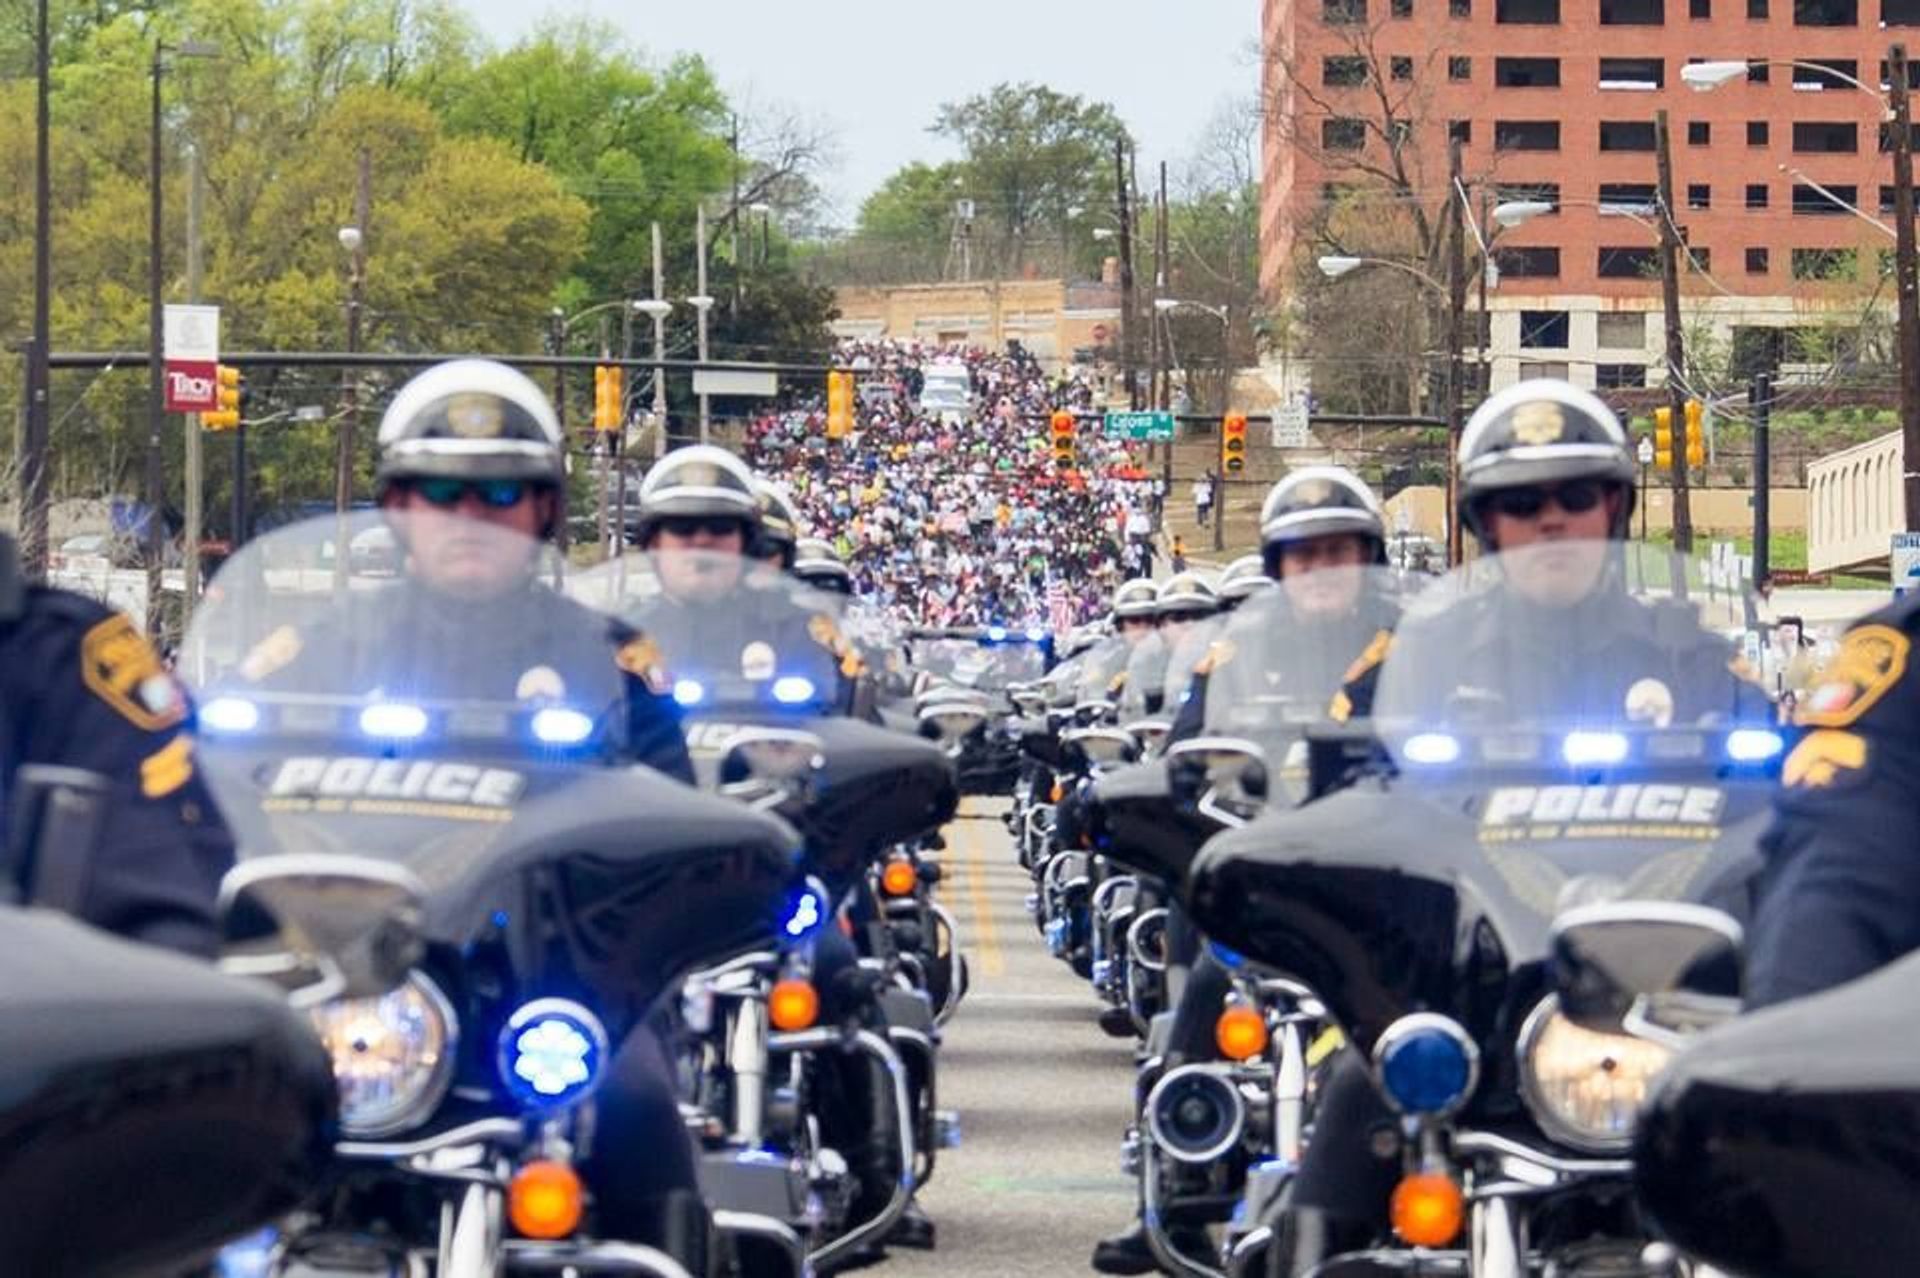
[1188,541,1784,1278]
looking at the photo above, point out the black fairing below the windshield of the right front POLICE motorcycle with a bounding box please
[1188,779,1770,1069]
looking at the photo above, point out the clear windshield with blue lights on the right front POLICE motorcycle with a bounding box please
[1373,541,1778,756]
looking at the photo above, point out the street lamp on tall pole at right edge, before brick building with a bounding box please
[1680,44,1920,530]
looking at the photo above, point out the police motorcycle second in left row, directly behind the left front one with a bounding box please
[572,551,958,1268]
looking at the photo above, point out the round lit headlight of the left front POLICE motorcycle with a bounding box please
[309,973,459,1136]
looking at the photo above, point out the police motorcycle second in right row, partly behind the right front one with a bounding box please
[1092,566,1400,1274]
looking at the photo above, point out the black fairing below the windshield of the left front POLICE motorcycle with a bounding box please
[207,741,799,1019]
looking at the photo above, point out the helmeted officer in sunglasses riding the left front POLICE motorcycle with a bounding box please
[242,359,707,1265]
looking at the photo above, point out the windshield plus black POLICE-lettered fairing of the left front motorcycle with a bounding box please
[179,497,793,988]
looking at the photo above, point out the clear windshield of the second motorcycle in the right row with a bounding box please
[1204,566,1402,740]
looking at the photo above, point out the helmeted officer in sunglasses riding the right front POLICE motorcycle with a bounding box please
[1273,378,1764,1278]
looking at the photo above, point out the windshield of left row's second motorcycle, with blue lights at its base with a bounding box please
[568,551,864,720]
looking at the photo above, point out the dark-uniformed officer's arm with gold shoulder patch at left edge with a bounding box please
[0,535,234,958]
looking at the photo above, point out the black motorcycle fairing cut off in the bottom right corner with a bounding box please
[1634,956,1920,1278]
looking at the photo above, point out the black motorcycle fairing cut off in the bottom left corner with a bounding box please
[0,910,334,1276]
